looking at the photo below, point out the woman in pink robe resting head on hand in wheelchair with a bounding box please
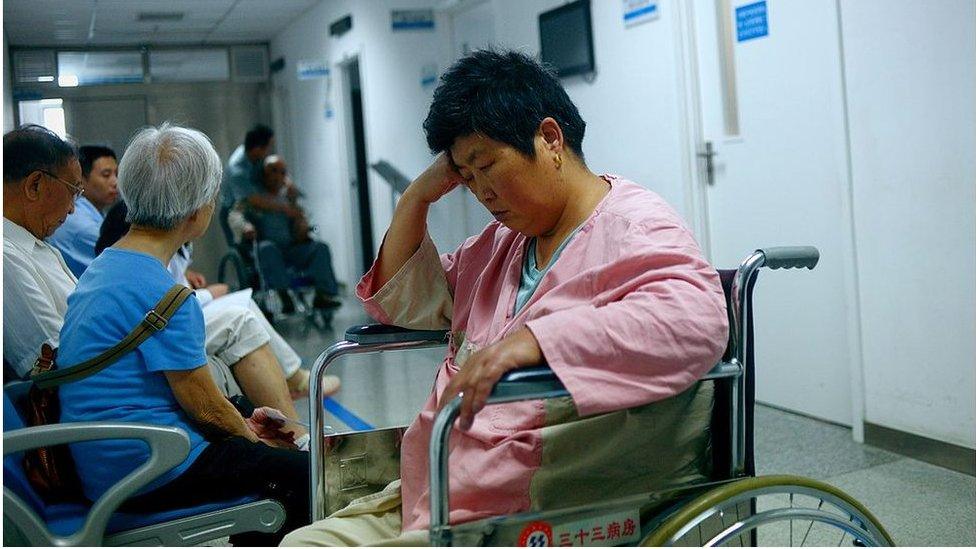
[284,51,728,545]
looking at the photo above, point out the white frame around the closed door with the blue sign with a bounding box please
[672,0,865,442]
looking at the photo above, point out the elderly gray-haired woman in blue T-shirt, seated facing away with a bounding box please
[59,125,309,545]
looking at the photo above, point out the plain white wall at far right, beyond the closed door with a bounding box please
[841,0,976,448]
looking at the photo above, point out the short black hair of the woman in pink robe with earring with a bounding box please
[424,50,586,159]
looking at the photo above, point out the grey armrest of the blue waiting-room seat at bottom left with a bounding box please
[3,422,190,546]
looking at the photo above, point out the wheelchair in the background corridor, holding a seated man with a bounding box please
[217,202,332,332]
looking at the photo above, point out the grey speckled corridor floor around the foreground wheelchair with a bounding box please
[272,302,976,546]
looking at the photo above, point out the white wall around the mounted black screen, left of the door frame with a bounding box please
[492,0,692,223]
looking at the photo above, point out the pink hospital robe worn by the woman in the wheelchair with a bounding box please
[357,175,728,531]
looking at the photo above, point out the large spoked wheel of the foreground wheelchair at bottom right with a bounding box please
[641,475,894,547]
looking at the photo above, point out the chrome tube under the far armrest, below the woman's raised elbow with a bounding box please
[308,340,444,522]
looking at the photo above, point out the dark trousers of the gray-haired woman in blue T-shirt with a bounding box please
[122,437,310,547]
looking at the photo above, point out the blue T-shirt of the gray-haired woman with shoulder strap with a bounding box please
[58,248,207,500]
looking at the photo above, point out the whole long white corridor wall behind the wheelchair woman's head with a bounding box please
[271,0,690,282]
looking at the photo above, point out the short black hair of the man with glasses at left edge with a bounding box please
[3,124,78,183]
